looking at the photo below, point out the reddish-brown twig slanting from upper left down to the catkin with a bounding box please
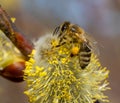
[0,6,33,59]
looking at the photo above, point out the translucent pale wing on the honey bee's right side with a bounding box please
[85,33,100,56]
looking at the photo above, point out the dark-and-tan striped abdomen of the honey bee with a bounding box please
[79,43,91,69]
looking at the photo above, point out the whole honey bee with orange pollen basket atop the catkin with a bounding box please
[53,22,98,69]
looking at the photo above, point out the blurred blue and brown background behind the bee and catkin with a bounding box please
[0,0,120,103]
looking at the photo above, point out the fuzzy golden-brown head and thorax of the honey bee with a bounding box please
[53,21,86,43]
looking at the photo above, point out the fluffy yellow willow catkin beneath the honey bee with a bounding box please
[24,33,109,103]
